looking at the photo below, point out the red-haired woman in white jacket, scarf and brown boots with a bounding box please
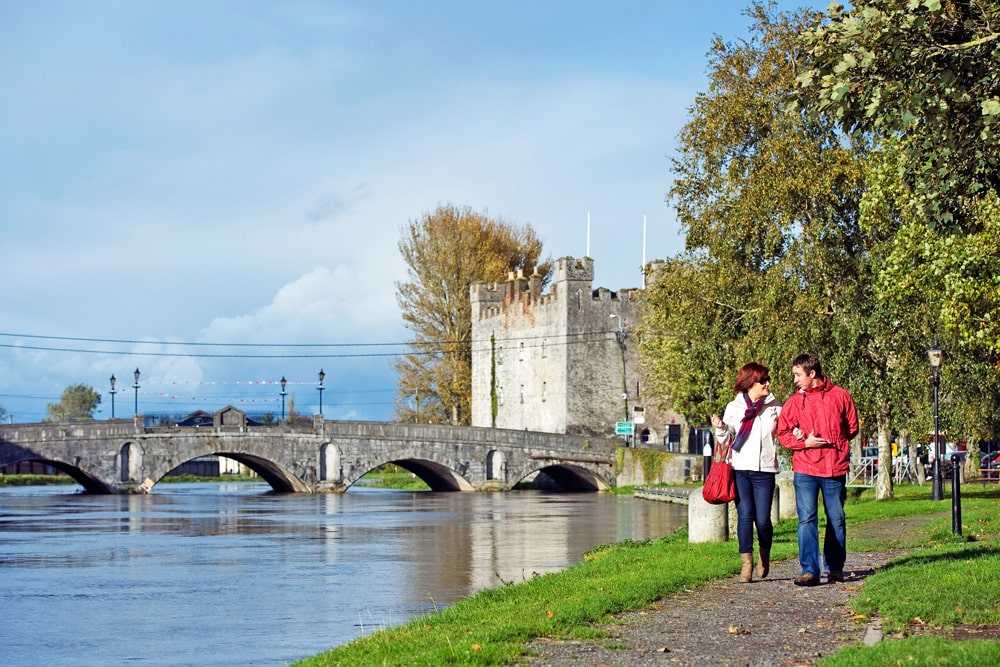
[712,361,781,584]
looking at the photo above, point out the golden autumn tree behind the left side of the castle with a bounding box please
[394,204,551,424]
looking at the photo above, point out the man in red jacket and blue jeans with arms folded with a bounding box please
[778,354,858,586]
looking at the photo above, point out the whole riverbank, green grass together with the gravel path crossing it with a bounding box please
[297,487,1000,667]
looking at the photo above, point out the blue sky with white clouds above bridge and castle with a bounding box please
[0,0,825,423]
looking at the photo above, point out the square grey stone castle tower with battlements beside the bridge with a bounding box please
[470,257,681,448]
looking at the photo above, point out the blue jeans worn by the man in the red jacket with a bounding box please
[794,472,847,577]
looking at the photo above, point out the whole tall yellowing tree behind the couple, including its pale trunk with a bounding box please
[644,3,926,498]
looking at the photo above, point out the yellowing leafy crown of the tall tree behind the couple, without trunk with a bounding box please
[642,3,862,421]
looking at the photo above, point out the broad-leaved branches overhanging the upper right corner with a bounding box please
[799,0,1000,228]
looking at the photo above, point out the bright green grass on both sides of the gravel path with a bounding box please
[296,487,1000,667]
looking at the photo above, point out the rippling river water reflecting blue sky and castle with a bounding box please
[0,483,687,666]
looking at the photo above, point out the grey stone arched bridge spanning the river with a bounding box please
[0,409,615,493]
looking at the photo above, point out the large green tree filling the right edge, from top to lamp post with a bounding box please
[799,0,1000,470]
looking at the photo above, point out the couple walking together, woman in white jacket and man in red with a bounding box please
[712,354,858,586]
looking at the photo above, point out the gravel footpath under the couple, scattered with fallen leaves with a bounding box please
[527,516,931,667]
